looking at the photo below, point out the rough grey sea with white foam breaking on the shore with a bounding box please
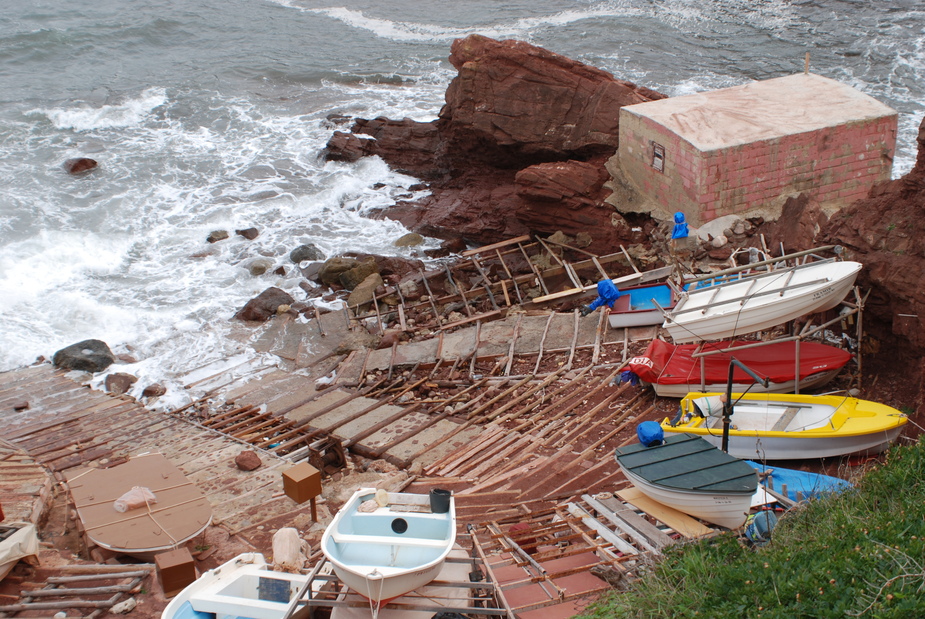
[0,0,925,403]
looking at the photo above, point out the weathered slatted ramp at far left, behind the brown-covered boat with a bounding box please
[0,364,314,533]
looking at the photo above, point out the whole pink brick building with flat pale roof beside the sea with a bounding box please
[617,74,897,226]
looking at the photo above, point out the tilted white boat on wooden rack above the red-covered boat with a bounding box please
[662,260,862,343]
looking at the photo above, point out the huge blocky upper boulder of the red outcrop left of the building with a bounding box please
[440,35,663,167]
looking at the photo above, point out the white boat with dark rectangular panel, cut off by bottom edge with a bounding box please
[161,552,309,619]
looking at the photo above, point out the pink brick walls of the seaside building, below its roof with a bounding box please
[620,108,897,225]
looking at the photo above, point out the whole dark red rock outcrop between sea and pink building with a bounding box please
[326,35,664,253]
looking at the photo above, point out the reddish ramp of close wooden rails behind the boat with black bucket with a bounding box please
[412,366,654,523]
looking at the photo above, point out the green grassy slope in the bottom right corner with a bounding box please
[582,441,925,619]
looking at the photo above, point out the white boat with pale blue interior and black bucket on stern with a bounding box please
[321,488,456,603]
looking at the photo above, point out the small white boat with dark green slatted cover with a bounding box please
[615,434,758,529]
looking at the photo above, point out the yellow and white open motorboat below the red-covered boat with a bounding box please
[661,393,908,460]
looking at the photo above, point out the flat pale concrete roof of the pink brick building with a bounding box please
[622,73,896,151]
